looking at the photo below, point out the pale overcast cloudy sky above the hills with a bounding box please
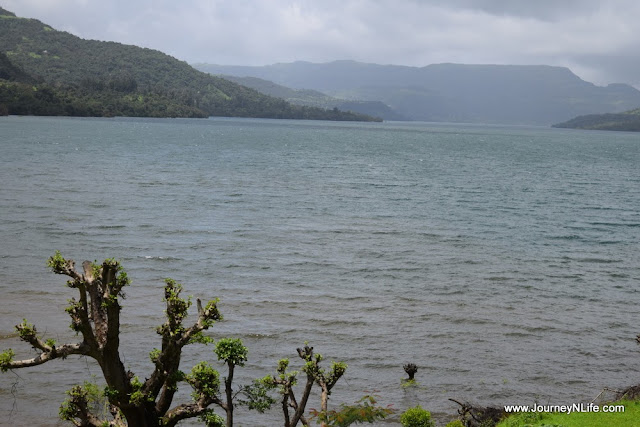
[5,0,640,88]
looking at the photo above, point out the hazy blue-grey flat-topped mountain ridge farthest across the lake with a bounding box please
[194,61,640,125]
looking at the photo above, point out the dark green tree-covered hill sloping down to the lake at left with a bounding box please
[0,8,380,120]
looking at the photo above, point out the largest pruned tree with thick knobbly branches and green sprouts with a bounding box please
[0,252,228,427]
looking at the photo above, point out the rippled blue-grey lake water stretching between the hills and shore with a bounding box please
[0,117,640,426]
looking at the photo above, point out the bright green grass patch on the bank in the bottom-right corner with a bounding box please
[497,400,640,427]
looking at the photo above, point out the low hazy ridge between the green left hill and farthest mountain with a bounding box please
[220,75,407,120]
